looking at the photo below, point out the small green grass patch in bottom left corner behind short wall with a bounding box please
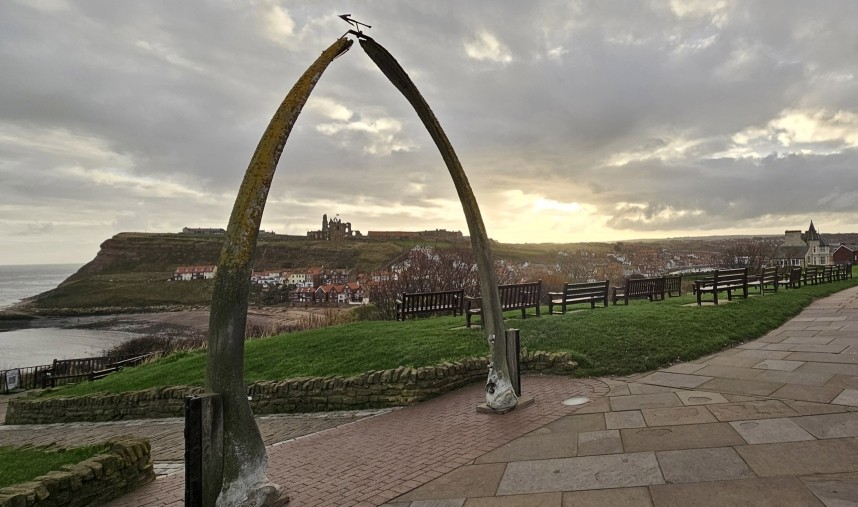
[0,445,107,488]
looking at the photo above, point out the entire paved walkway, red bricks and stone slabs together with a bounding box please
[8,288,858,507]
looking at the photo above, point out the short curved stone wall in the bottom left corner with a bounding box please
[0,437,155,507]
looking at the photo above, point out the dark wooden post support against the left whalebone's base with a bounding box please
[185,393,223,507]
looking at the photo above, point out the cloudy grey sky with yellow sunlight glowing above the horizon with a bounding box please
[0,0,858,264]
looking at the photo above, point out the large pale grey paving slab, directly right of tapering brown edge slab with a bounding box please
[497,452,664,495]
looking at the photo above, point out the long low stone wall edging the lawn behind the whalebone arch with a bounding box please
[6,350,577,424]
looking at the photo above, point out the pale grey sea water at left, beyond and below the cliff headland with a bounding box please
[0,264,137,370]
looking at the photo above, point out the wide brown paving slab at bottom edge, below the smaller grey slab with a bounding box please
[650,477,823,507]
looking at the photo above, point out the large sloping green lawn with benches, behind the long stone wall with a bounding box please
[44,278,858,396]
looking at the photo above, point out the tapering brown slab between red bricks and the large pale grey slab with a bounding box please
[396,463,507,502]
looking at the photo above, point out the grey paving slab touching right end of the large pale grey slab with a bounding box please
[655,447,756,484]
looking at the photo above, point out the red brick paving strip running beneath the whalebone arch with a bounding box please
[111,376,608,506]
